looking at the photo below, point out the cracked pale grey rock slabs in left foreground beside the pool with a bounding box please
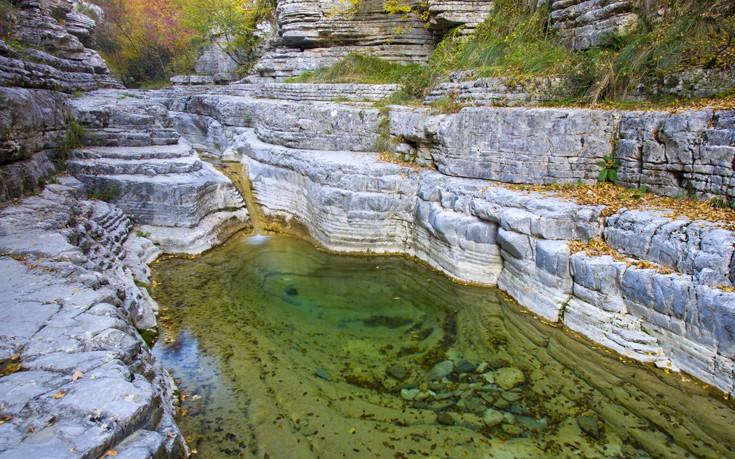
[0,177,187,458]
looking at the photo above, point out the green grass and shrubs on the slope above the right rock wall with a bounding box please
[295,0,735,103]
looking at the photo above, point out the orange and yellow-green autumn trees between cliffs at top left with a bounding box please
[94,0,274,86]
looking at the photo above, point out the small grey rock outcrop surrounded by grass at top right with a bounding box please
[549,0,638,50]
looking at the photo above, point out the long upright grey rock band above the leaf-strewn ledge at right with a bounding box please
[391,107,735,201]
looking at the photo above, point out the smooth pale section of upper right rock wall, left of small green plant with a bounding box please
[391,108,615,184]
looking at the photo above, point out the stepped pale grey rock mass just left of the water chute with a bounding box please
[68,92,253,253]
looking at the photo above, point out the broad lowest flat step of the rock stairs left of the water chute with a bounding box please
[67,156,202,176]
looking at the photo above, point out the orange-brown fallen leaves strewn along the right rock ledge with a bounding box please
[506,183,735,231]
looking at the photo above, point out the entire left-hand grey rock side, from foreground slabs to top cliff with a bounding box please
[0,0,248,458]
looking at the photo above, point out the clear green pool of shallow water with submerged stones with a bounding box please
[154,236,735,458]
